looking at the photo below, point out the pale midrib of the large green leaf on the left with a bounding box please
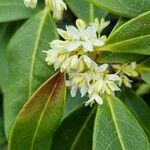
[28,8,48,98]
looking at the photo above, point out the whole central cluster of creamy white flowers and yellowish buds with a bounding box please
[45,19,137,106]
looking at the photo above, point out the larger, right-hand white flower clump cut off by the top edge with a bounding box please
[46,0,67,20]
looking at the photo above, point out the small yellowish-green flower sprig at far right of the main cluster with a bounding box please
[112,62,138,88]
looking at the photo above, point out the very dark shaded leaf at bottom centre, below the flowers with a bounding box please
[52,106,95,150]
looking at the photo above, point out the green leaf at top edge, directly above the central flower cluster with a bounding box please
[65,0,107,23]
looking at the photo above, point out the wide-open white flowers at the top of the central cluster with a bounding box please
[57,19,104,52]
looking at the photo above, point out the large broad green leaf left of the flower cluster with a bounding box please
[4,9,57,135]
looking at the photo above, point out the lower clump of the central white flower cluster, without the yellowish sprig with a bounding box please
[66,61,120,106]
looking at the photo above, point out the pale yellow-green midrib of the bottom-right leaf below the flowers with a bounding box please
[106,97,126,150]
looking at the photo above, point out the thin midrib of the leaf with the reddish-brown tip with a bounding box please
[31,77,60,150]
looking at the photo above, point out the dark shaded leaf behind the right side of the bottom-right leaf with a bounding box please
[119,88,150,137]
